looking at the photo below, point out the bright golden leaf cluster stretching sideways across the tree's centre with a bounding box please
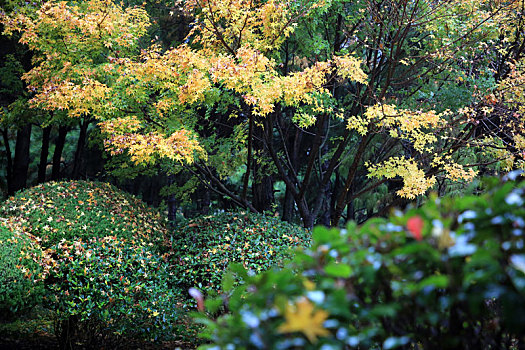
[118,45,366,116]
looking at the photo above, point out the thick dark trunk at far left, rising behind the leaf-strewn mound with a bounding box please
[10,124,31,194]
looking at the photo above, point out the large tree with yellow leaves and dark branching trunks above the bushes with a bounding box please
[2,0,522,227]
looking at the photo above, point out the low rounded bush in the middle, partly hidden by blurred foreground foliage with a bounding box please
[170,211,309,295]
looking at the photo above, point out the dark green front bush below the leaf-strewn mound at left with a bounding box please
[45,237,177,347]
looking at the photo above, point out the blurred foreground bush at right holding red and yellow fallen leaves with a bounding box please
[196,182,525,349]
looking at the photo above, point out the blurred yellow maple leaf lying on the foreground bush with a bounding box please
[277,298,330,343]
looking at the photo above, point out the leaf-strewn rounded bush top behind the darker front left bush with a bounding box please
[0,181,166,248]
